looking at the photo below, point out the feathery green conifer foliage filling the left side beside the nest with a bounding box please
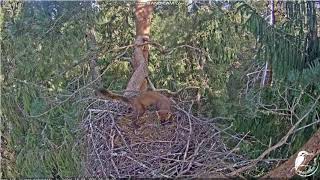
[1,2,96,177]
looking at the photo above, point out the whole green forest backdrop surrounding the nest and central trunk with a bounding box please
[0,1,320,177]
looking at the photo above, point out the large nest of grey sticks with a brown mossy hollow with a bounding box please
[82,100,243,178]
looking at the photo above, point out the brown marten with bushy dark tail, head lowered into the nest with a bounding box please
[96,89,172,126]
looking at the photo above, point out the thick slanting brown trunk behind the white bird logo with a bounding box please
[263,129,320,179]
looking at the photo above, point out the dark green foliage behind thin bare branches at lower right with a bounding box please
[229,82,320,162]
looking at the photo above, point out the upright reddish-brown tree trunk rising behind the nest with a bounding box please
[124,0,153,96]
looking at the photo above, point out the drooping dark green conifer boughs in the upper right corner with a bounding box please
[236,1,320,79]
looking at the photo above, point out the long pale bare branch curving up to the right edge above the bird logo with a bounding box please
[228,96,320,176]
